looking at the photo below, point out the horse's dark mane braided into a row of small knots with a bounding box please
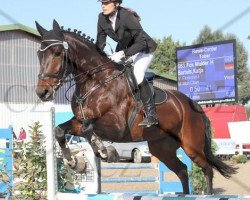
[61,26,107,57]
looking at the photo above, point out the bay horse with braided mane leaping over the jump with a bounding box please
[36,20,236,194]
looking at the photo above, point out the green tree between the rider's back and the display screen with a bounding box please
[150,36,183,76]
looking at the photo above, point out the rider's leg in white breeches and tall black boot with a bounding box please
[133,52,158,127]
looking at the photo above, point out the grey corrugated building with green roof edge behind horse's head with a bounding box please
[0,24,70,136]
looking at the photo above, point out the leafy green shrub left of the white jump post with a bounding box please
[13,122,47,200]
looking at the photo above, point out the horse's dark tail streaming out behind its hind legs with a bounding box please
[202,113,238,178]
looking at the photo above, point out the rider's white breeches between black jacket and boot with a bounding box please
[132,52,154,84]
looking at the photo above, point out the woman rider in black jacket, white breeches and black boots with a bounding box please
[96,0,158,127]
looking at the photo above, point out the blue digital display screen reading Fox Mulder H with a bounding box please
[176,40,237,104]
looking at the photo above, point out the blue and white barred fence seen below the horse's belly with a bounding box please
[101,149,192,194]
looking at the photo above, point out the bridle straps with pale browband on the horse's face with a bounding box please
[38,40,69,91]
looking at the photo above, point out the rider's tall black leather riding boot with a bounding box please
[139,78,158,127]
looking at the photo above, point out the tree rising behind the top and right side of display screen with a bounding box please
[193,26,250,104]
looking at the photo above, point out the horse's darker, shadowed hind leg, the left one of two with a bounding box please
[148,135,189,194]
